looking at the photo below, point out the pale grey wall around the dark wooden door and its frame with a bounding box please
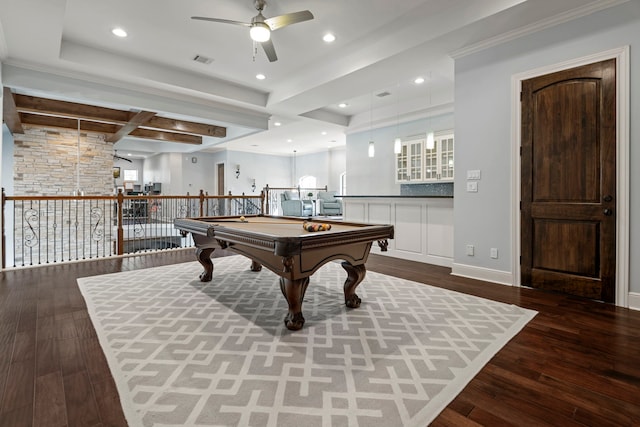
[454,1,640,292]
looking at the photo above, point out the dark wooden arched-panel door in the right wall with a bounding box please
[520,60,616,302]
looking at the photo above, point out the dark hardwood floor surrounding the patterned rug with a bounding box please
[0,250,640,427]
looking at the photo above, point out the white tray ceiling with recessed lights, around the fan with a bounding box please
[0,0,624,156]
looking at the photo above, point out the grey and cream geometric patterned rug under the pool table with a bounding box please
[78,255,536,427]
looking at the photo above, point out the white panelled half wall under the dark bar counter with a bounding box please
[343,196,453,267]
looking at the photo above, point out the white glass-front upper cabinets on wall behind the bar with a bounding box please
[396,131,453,183]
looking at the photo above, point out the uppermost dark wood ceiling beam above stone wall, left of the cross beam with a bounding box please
[15,95,131,125]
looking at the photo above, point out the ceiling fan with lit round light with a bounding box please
[191,0,313,62]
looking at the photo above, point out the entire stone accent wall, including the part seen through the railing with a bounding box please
[5,126,115,265]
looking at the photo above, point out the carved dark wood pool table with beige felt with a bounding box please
[174,215,393,330]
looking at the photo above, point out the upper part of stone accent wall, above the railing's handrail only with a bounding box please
[13,126,113,196]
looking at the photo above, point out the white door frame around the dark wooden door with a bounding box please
[511,46,629,307]
